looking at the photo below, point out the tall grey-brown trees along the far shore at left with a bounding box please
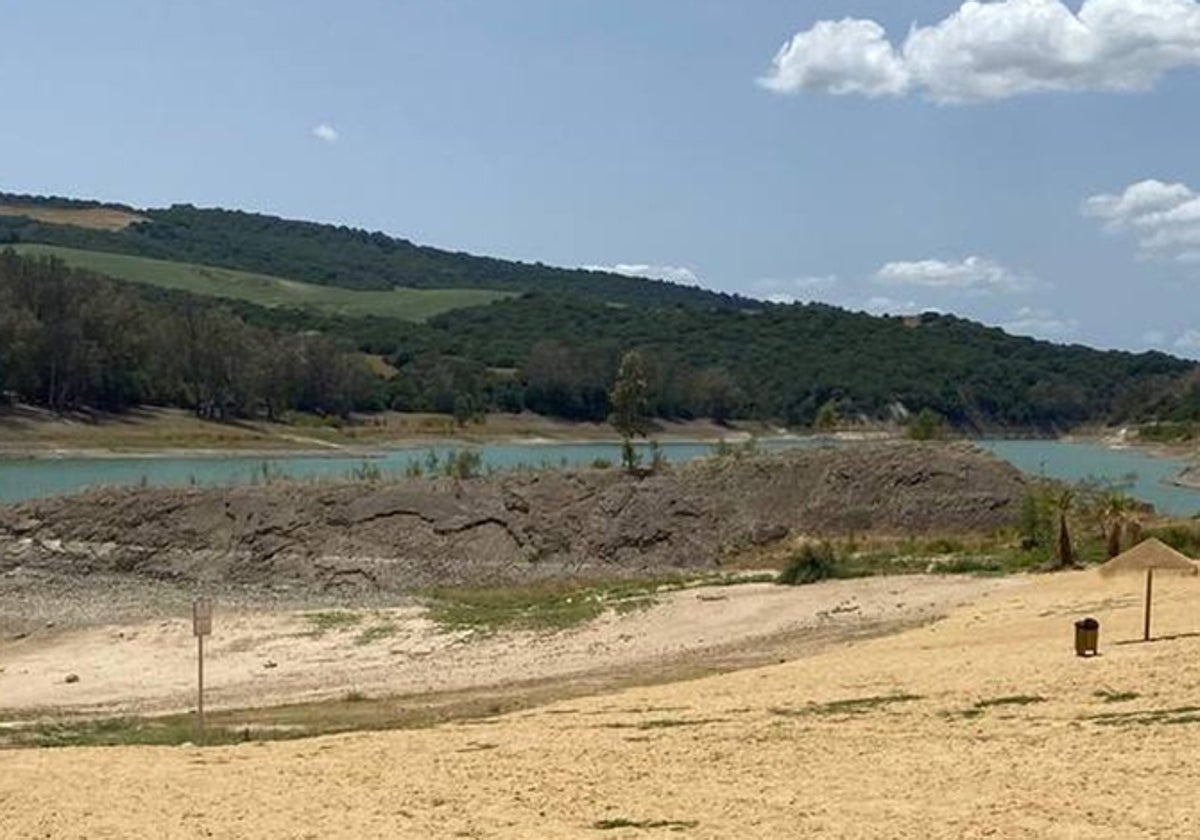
[0,248,384,420]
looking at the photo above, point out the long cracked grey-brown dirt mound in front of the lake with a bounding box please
[0,443,1022,592]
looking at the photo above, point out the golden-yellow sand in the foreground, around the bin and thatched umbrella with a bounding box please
[0,572,1200,840]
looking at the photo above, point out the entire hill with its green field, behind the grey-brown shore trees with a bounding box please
[0,188,1200,431]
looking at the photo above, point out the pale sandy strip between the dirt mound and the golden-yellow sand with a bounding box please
[0,576,1019,715]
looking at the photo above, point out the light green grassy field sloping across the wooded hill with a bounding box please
[14,244,511,320]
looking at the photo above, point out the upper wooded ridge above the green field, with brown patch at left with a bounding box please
[0,193,748,308]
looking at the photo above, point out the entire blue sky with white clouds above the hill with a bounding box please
[0,0,1200,358]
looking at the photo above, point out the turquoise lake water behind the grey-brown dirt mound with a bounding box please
[0,438,1200,516]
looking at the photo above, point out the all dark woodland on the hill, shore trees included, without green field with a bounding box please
[0,189,1200,430]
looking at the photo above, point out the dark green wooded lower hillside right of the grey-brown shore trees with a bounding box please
[386,295,1200,428]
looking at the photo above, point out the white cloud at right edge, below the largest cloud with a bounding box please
[1084,180,1200,263]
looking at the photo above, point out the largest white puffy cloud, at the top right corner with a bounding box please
[758,0,1200,103]
